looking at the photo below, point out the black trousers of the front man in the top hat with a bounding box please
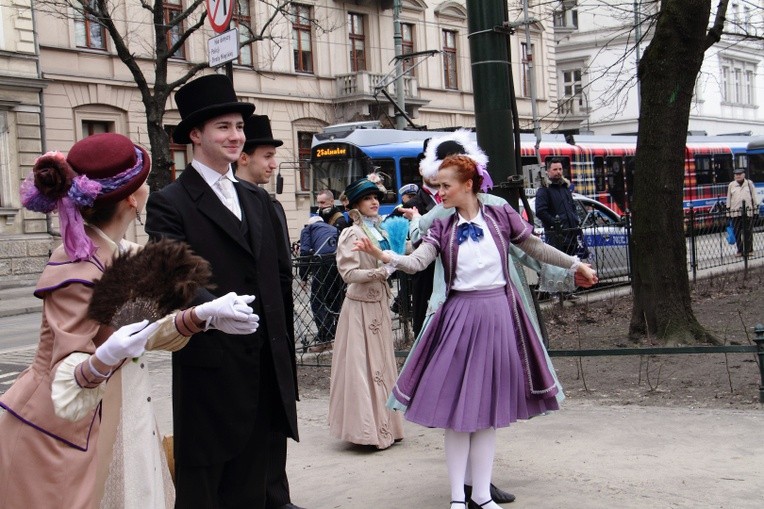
[175,342,278,509]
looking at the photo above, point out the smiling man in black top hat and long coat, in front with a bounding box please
[146,74,298,509]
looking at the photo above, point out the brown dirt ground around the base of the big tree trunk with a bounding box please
[298,269,764,409]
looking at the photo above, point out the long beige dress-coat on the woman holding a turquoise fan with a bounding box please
[329,216,403,449]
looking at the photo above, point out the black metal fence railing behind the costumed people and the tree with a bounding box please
[292,205,764,366]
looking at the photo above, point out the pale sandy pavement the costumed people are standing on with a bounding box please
[0,289,764,509]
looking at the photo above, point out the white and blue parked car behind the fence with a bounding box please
[520,193,630,280]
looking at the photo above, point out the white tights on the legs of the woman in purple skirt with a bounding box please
[445,428,501,509]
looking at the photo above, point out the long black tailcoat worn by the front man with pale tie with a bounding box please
[146,165,298,465]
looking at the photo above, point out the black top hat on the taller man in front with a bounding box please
[172,74,255,143]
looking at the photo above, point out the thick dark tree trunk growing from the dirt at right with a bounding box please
[629,0,713,343]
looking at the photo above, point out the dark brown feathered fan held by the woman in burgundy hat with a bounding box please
[88,239,212,329]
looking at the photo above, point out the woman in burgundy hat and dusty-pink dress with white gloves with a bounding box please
[0,133,257,509]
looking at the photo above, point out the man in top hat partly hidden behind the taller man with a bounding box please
[236,115,300,509]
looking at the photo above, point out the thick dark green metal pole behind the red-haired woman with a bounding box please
[467,0,518,209]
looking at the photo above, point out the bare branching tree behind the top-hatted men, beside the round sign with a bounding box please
[37,0,302,190]
